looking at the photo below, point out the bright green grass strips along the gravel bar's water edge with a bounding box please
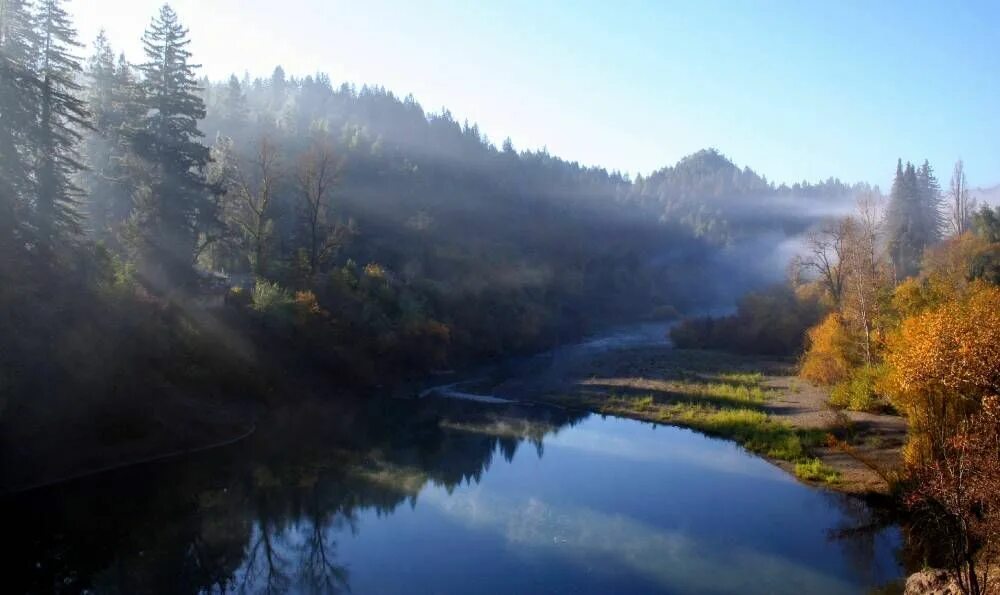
[577,372,839,483]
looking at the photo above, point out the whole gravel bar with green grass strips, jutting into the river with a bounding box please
[476,344,906,494]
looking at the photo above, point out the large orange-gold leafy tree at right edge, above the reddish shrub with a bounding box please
[883,282,1000,465]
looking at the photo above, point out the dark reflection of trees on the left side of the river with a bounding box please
[8,394,583,593]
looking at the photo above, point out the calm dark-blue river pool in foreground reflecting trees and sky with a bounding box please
[4,400,900,593]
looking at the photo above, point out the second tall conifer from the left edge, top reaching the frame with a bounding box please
[33,0,89,257]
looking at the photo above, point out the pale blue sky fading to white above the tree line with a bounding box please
[67,0,1000,188]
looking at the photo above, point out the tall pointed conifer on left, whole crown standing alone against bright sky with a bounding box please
[133,5,215,290]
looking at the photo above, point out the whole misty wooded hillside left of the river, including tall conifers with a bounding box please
[0,0,872,416]
